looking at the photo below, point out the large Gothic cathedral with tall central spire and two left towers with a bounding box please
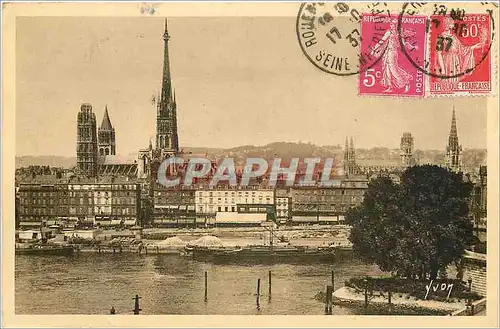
[76,20,179,179]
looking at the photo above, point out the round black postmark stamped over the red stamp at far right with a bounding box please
[397,2,495,80]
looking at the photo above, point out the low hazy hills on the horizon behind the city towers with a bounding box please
[16,142,486,168]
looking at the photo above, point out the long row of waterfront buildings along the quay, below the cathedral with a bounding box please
[16,176,368,228]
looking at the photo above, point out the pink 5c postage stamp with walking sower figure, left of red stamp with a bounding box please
[359,14,427,97]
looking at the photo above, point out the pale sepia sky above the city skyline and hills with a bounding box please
[16,17,486,156]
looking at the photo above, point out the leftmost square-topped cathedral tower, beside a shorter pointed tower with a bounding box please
[76,103,97,177]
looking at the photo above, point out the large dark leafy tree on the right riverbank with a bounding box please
[346,165,473,279]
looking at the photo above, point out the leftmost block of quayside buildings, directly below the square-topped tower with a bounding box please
[18,182,140,228]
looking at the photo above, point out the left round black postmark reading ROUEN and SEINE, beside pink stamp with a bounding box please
[296,2,382,76]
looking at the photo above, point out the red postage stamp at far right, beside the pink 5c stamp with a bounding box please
[429,14,492,95]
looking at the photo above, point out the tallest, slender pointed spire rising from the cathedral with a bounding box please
[156,19,179,158]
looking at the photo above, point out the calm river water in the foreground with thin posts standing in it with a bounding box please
[15,253,381,315]
